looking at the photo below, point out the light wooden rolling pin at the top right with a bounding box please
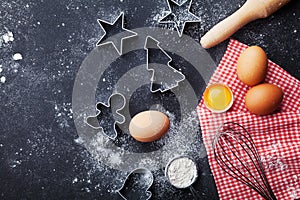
[200,0,290,48]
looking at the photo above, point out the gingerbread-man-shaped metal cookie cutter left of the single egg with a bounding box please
[86,93,126,140]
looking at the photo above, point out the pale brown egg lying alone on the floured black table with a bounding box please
[129,110,170,142]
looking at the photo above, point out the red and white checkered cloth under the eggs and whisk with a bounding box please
[197,40,300,200]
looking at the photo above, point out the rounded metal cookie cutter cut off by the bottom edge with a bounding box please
[117,168,154,200]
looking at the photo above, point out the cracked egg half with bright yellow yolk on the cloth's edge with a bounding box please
[204,84,232,110]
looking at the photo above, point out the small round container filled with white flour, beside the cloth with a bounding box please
[167,157,197,188]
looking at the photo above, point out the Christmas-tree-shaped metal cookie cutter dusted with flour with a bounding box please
[144,36,185,93]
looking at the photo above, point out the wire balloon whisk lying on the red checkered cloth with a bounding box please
[212,122,276,200]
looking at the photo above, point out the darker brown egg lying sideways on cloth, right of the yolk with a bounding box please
[245,83,283,115]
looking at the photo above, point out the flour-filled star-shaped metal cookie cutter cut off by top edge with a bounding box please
[159,0,200,37]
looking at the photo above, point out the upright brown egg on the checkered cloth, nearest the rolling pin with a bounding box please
[236,46,268,86]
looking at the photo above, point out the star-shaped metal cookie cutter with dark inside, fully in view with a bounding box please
[96,12,138,56]
